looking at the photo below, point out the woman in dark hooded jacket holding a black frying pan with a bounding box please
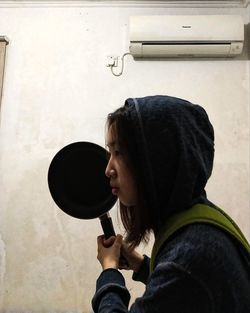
[92,96,250,313]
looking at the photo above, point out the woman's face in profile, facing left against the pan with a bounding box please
[105,126,138,206]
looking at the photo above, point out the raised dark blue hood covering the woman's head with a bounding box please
[125,96,214,232]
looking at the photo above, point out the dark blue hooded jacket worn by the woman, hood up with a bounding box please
[92,96,250,313]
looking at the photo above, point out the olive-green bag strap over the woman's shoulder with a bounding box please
[150,204,250,272]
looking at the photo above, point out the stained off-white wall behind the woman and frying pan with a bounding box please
[0,4,250,313]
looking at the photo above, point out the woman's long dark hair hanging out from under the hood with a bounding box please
[106,106,153,248]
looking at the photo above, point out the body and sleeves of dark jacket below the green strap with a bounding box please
[93,224,250,313]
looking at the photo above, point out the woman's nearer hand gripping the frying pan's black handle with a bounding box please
[97,235,122,270]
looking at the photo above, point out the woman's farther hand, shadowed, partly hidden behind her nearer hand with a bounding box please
[119,241,144,272]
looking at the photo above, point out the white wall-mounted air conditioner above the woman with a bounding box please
[129,15,244,58]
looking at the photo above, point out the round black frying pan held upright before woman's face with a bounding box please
[48,141,117,238]
